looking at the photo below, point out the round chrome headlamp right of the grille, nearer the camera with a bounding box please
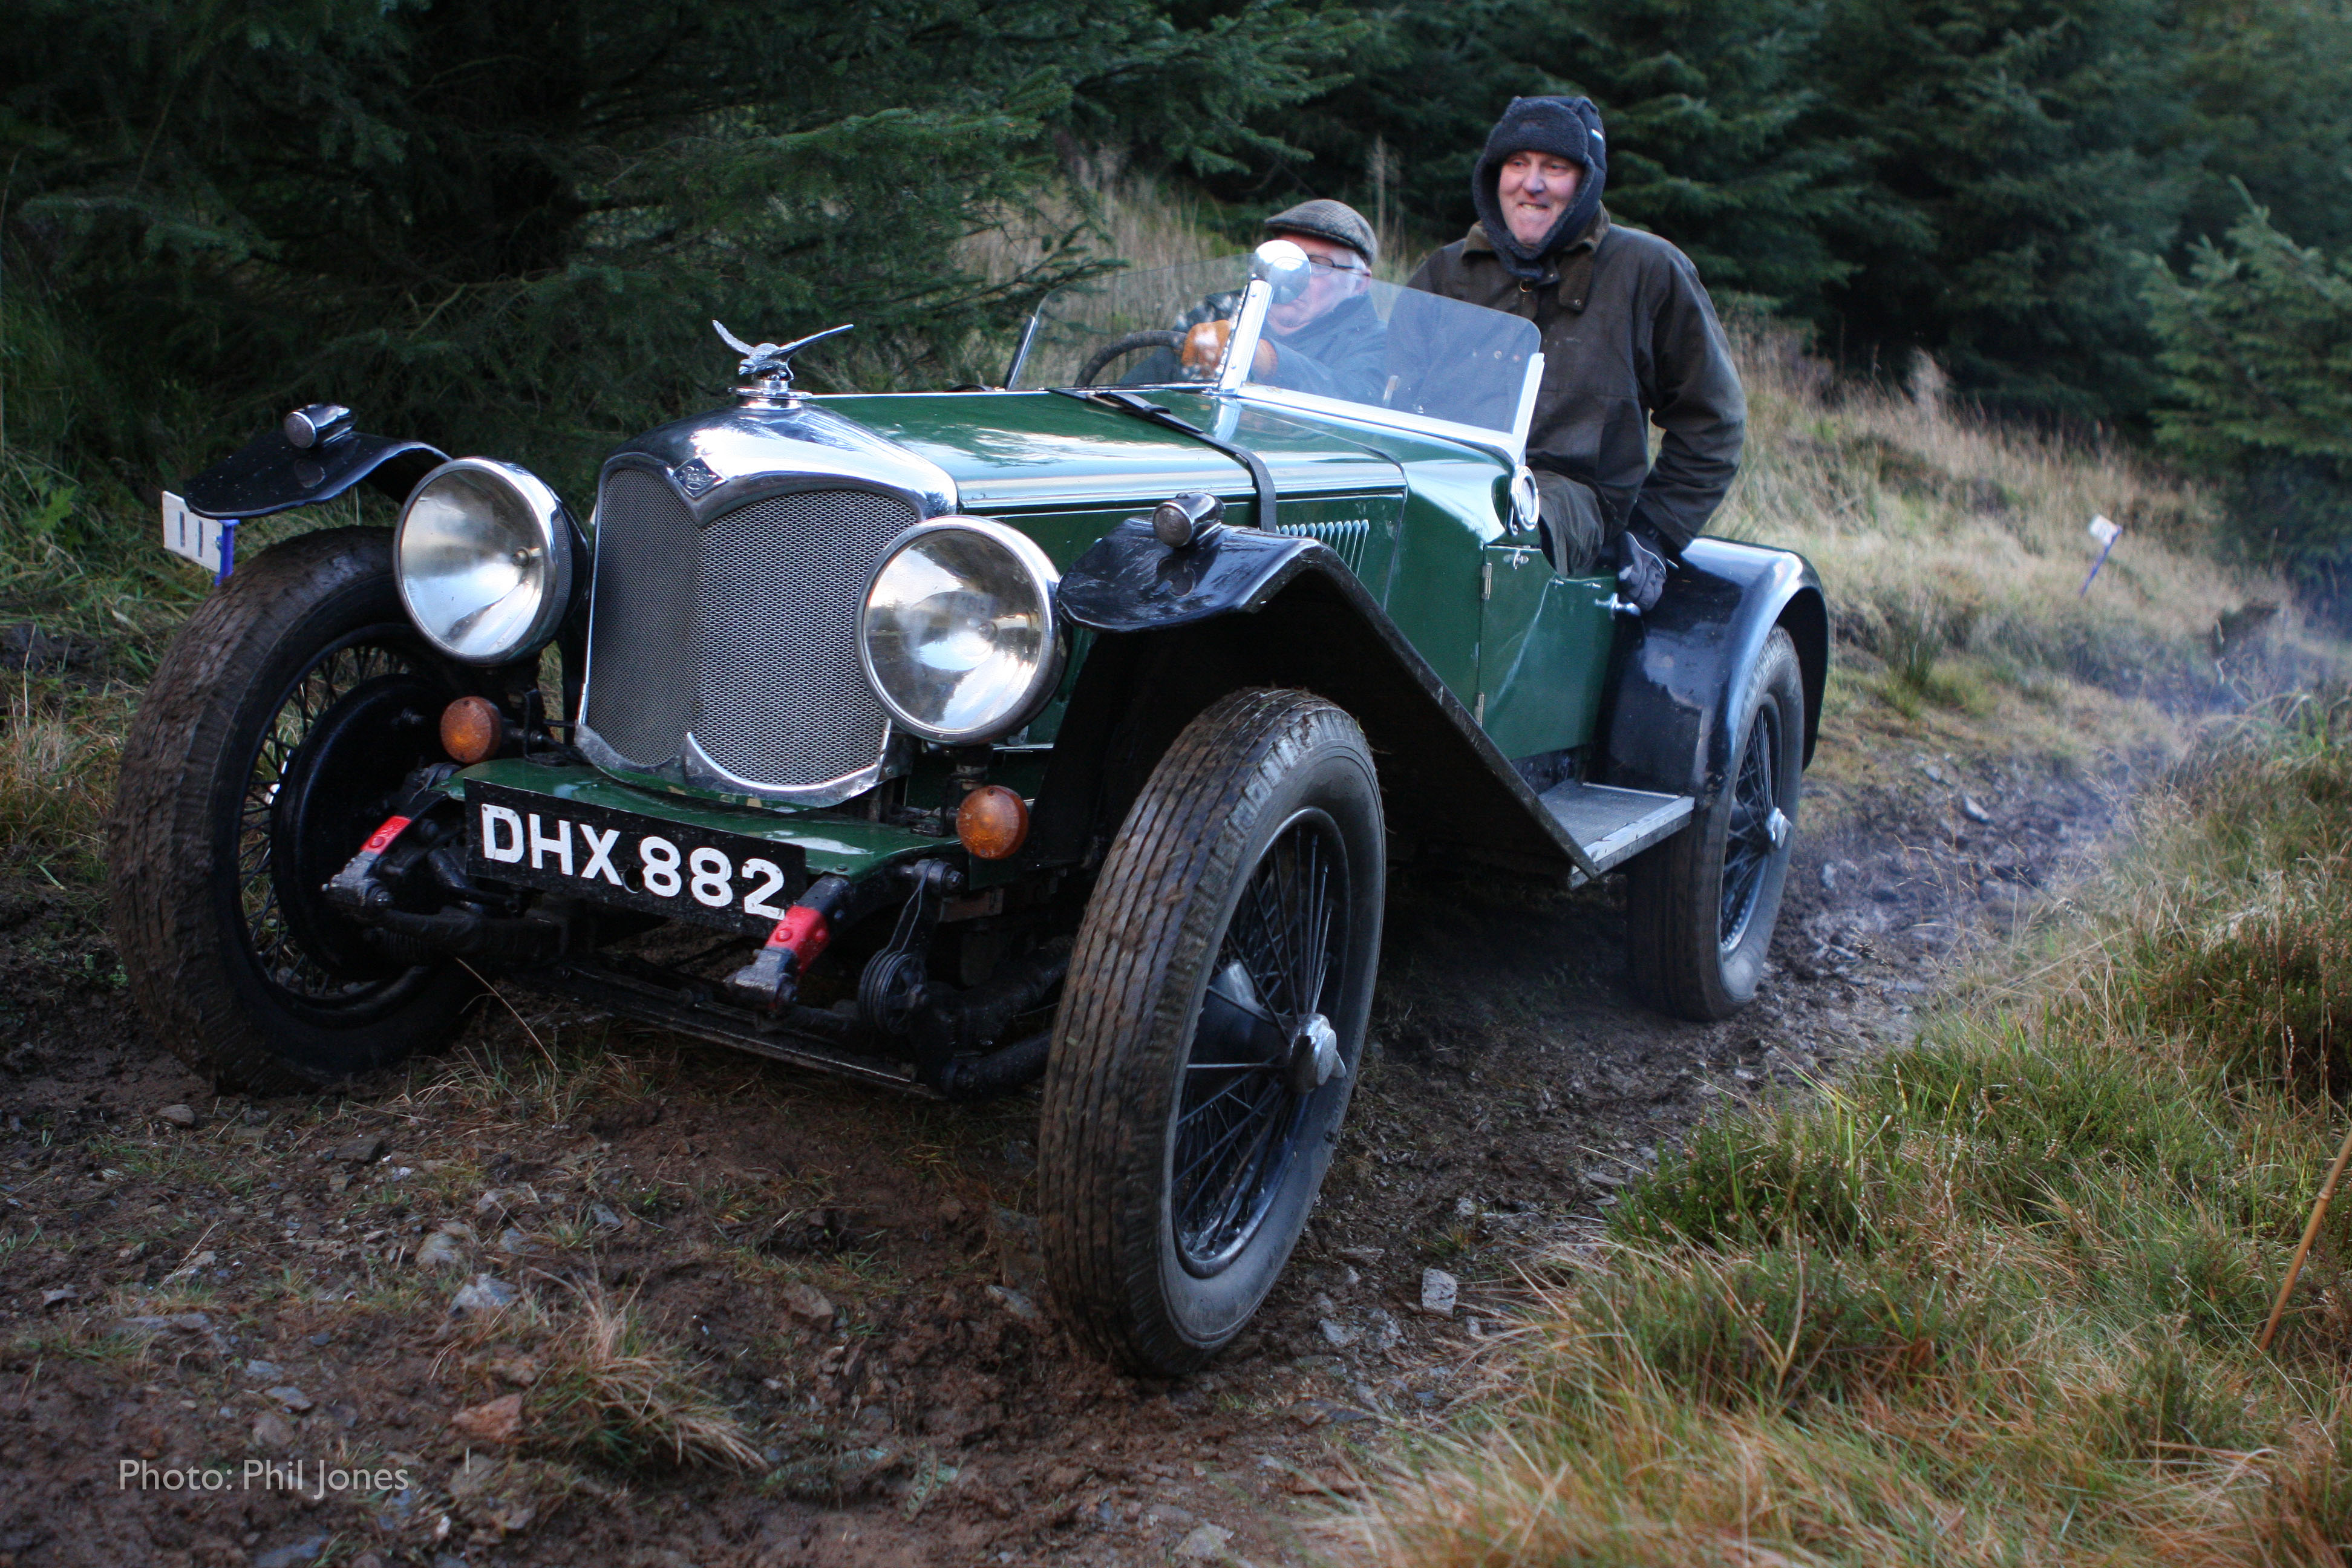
[858,517,1063,745]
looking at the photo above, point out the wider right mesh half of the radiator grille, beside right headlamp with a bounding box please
[694,489,915,785]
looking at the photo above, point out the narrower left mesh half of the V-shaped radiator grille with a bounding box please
[588,468,694,766]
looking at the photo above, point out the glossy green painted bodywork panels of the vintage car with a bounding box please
[466,393,1613,886]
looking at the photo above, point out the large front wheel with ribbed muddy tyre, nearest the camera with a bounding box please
[1039,691,1385,1375]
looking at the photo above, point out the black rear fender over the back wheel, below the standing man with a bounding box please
[1599,538,1830,802]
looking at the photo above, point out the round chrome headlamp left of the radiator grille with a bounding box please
[393,459,572,665]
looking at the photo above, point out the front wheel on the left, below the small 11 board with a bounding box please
[108,529,477,1091]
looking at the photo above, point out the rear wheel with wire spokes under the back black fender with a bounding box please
[1625,628,1804,1022]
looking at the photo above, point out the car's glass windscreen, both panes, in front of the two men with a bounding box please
[1014,256,1543,435]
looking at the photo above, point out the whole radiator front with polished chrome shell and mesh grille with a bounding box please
[578,395,957,806]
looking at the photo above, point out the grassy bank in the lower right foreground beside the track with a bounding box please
[1333,701,2352,1568]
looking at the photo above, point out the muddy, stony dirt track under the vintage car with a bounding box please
[0,757,2110,1568]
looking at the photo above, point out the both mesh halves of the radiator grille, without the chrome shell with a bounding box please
[586,468,915,790]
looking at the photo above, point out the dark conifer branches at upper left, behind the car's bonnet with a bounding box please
[0,0,1357,491]
